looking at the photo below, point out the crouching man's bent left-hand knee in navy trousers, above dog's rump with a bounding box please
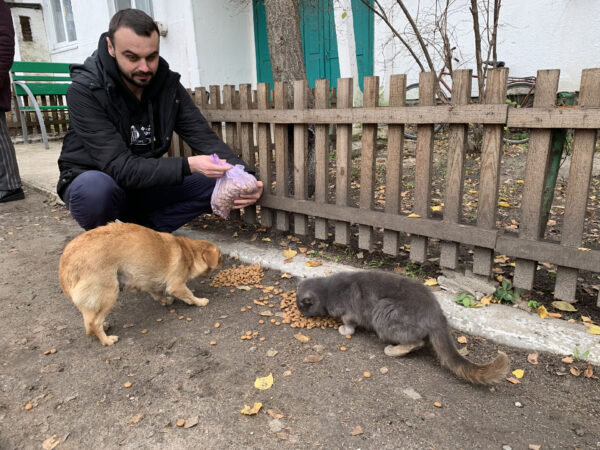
[65,170,127,230]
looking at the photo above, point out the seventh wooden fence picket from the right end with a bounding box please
[358,77,379,251]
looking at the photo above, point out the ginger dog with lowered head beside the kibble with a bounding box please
[58,223,221,345]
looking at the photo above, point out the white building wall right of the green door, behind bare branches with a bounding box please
[374,0,600,95]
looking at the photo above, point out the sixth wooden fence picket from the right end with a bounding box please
[383,75,406,256]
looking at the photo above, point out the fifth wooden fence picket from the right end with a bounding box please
[410,72,436,263]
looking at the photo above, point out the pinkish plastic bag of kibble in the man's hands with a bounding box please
[210,154,258,219]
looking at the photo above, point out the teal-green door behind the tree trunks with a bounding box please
[253,0,373,88]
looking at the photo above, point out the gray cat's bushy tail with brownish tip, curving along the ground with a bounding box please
[429,327,509,384]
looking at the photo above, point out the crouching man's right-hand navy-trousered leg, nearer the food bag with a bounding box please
[127,173,216,233]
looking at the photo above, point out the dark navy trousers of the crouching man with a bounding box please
[65,170,216,233]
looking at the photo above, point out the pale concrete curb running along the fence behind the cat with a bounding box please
[176,228,600,365]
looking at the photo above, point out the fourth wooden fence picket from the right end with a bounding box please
[440,70,472,269]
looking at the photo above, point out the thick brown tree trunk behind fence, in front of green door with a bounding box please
[265,0,315,196]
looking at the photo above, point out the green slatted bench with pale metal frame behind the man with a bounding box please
[10,61,71,148]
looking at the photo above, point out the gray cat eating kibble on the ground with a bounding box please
[296,272,509,384]
